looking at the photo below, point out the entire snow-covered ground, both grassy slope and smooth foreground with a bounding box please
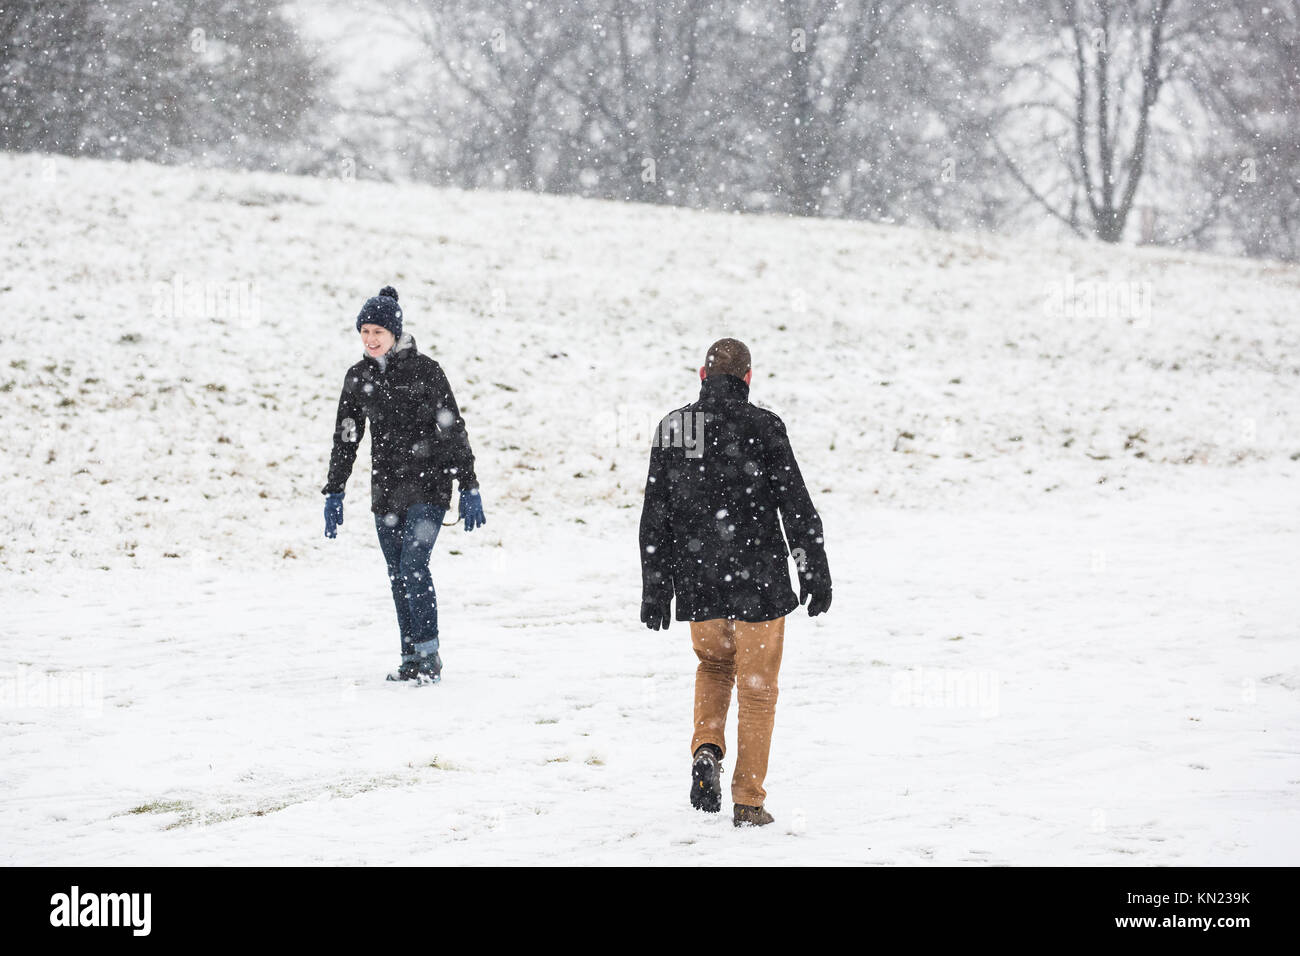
[0,155,1300,865]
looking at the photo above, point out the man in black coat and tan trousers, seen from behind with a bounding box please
[641,338,831,826]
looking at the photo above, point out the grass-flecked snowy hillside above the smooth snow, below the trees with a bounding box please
[0,155,1300,571]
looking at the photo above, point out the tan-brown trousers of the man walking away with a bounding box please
[690,618,785,806]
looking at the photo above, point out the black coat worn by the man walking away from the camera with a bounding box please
[641,375,831,622]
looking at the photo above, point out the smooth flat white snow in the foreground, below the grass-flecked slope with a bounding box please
[0,485,1300,865]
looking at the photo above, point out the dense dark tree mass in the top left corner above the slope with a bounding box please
[0,0,322,165]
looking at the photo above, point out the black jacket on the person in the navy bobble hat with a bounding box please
[321,334,478,515]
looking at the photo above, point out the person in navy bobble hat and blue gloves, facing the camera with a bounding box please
[321,286,486,683]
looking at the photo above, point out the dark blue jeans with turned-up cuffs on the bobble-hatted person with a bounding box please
[374,505,447,662]
